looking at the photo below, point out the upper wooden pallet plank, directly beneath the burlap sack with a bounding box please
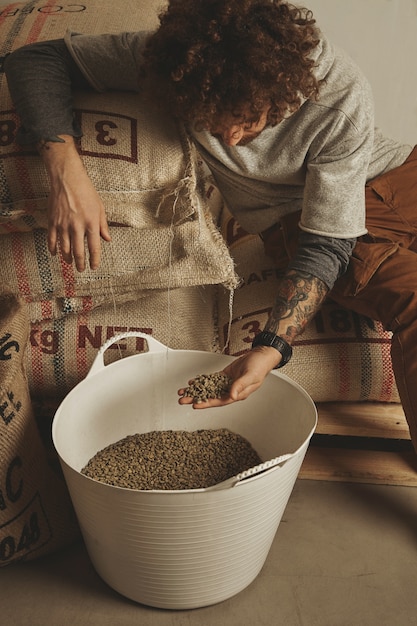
[316,402,410,440]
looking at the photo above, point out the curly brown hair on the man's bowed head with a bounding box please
[143,0,319,129]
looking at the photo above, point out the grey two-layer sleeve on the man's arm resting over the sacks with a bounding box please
[4,33,145,144]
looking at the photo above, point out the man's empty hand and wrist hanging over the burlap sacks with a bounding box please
[41,135,110,272]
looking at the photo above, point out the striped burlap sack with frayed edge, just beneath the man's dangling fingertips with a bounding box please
[0,207,236,312]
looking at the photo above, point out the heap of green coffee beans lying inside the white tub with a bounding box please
[82,429,262,490]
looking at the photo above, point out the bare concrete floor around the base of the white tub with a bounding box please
[0,480,417,626]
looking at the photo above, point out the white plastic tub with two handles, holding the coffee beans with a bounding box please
[52,332,317,609]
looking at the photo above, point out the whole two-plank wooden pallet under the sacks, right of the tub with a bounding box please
[299,402,417,487]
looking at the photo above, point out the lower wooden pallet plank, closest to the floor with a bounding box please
[299,446,417,487]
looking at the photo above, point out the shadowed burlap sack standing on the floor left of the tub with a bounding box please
[0,293,79,566]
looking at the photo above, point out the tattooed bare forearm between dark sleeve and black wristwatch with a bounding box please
[265,270,328,343]
